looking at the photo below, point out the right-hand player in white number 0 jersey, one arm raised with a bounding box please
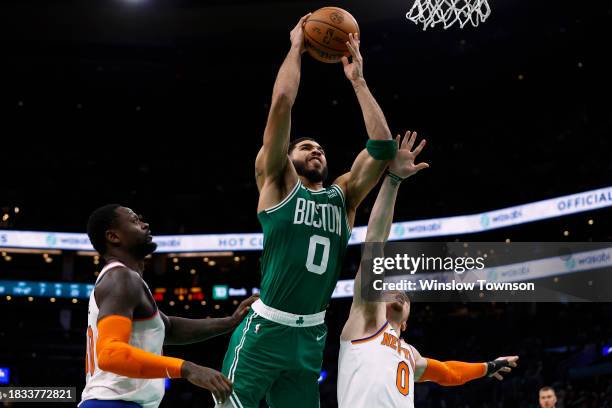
[337,133,518,408]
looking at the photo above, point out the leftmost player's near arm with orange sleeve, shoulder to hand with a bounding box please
[95,268,232,401]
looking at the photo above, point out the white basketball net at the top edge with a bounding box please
[406,0,491,30]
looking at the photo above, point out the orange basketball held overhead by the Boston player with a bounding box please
[304,7,359,63]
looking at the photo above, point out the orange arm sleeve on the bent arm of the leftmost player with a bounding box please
[96,315,184,378]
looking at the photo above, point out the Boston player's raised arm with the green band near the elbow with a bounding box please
[336,34,397,222]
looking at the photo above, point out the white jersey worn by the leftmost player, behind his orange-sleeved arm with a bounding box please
[81,262,165,408]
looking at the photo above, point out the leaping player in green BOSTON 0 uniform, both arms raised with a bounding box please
[223,15,397,408]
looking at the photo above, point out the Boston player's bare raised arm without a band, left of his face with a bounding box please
[255,14,310,191]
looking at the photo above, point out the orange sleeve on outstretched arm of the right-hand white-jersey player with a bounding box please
[420,358,487,385]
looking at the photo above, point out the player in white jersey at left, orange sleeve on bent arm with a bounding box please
[79,204,257,408]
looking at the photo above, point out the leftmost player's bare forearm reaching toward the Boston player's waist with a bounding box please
[162,295,259,345]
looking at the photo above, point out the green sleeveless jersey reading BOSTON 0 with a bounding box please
[257,180,350,314]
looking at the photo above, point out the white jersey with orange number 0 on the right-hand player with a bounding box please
[338,323,415,408]
